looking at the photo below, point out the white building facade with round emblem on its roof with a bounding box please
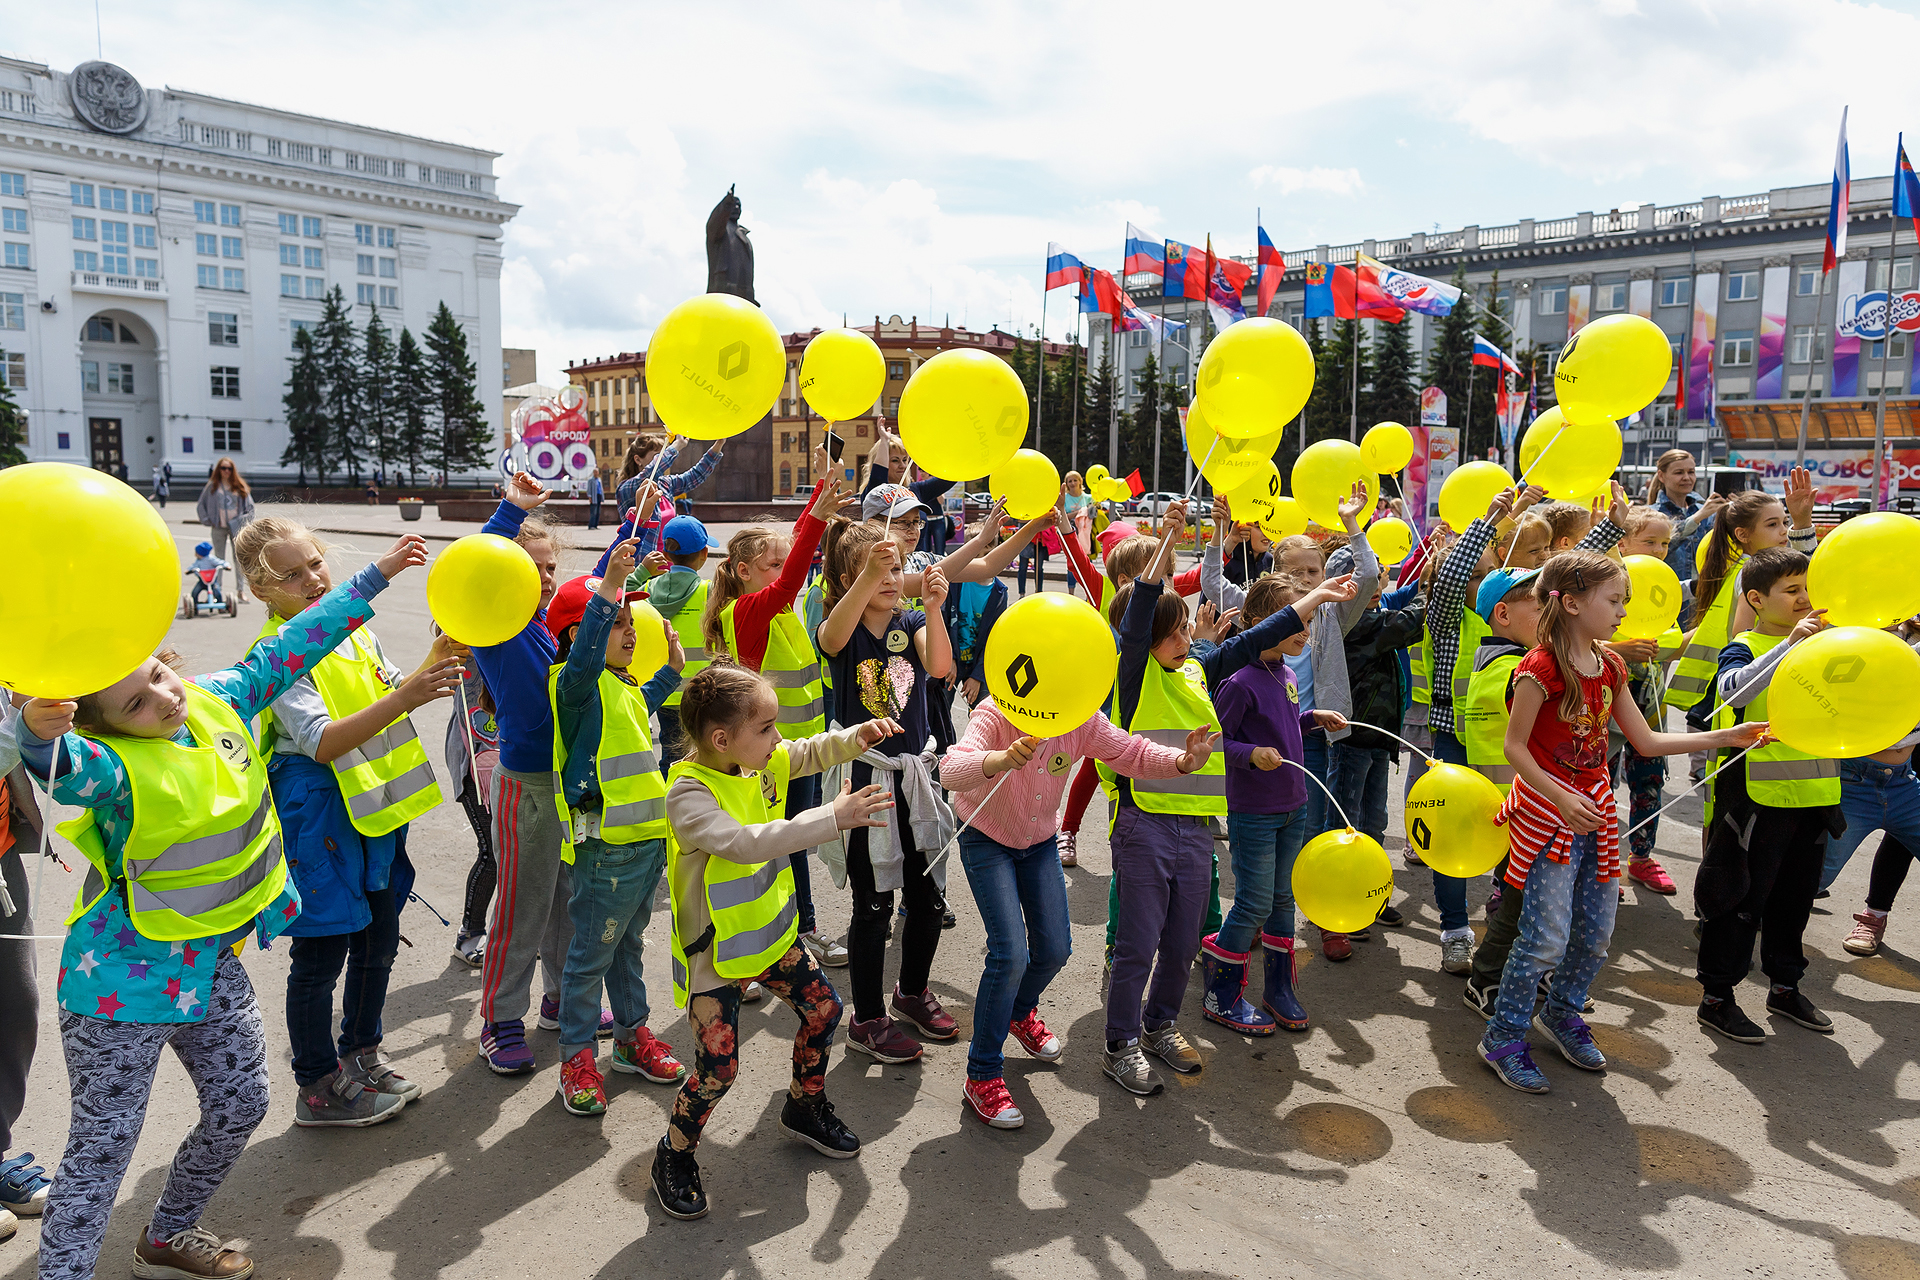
[0,58,518,484]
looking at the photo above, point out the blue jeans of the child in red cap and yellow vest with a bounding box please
[561,837,666,1061]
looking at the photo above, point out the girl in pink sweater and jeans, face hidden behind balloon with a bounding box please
[941,700,1208,1128]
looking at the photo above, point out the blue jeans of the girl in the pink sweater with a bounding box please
[960,827,1073,1080]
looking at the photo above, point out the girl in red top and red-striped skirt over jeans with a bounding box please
[1480,551,1766,1094]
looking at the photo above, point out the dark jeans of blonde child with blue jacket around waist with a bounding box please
[286,889,399,1084]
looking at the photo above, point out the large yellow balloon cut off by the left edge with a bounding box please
[0,462,178,694]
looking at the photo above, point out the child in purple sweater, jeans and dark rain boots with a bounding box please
[1200,574,1346,1036]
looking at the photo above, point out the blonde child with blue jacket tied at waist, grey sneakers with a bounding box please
[234,516,465,1126]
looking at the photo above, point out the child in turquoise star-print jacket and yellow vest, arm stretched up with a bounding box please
[17,535,426,1280]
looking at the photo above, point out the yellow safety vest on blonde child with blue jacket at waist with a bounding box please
[253,616,440,835]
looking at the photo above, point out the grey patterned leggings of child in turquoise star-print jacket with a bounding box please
[40,950,267,1280]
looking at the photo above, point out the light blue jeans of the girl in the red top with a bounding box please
[1486,833,1620,1046]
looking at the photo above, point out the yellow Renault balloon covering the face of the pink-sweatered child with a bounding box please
[983,591,1119,737]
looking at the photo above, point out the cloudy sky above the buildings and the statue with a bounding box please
[15,0,1920,382]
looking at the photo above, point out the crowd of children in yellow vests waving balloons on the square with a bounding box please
[0,443,1920,1278]
